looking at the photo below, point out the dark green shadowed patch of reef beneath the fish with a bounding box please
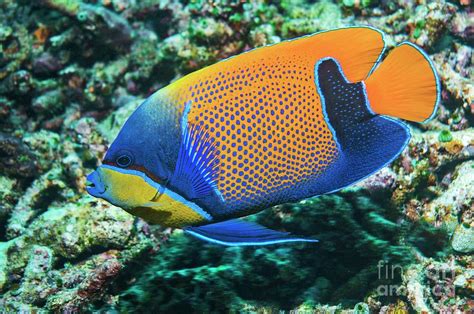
[111,192,422,313]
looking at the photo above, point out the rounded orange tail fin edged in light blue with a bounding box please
[365,42,440,122]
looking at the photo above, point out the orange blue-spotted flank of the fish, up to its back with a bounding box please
[162,29,383,208]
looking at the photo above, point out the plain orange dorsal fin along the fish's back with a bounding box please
[166,26,386,95]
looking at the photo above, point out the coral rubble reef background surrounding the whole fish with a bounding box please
[0,0,474,313]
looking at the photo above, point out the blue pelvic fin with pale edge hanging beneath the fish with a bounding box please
[184,219,318,246]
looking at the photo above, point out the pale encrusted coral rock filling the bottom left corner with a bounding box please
[0,197,156,311]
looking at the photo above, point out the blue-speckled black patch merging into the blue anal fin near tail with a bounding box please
[314,58,410,194]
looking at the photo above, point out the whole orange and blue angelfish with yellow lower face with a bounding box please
[87,27,440,245]
